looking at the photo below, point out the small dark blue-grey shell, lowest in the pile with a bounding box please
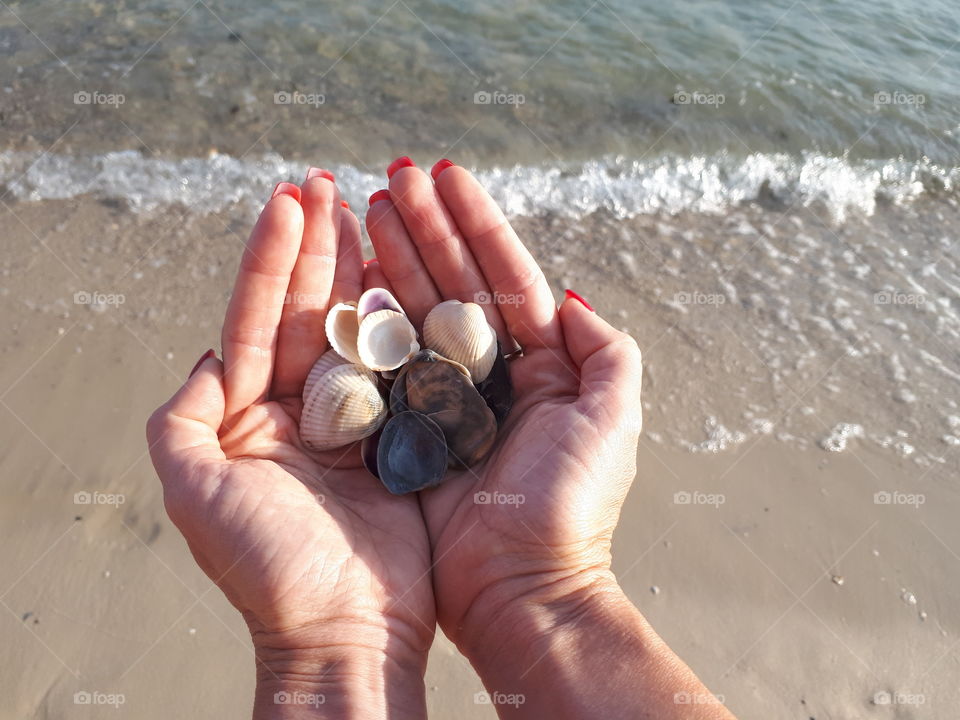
[377,411,447,495]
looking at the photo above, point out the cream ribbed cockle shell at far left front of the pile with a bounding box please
[300,364,387,450]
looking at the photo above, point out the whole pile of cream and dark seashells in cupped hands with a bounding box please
[300,288,513,495]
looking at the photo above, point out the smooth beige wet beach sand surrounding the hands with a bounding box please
[0,199,960,720]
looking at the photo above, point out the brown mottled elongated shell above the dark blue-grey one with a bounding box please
[404,352,497,468]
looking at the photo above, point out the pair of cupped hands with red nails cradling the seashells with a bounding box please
[147,158,641,717]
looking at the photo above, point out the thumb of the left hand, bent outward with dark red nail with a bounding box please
[147,351,225,486]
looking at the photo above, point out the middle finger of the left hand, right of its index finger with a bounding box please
[271,168,341,398]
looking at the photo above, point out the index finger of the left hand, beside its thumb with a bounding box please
[222,183,303,425]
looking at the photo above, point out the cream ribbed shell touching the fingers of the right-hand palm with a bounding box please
[423,300,497,383]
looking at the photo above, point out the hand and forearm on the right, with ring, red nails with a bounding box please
[367,162,730,718]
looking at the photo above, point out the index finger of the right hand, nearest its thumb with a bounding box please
[436,161,563,351]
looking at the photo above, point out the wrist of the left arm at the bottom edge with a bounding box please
[253,623,426,720]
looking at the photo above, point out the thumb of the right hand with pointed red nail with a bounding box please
[560,291,643,433]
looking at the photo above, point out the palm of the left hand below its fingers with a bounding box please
[178,394,433,632]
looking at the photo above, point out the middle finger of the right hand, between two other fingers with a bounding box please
[390,160,509,343]
